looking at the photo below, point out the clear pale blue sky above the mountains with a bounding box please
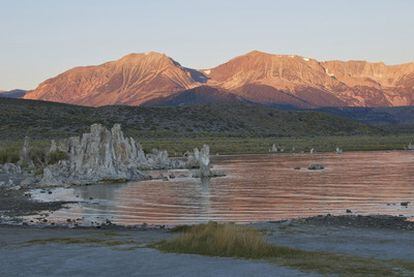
[0,0,414,90]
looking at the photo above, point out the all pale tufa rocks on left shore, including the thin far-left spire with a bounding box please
[0,124,222,186]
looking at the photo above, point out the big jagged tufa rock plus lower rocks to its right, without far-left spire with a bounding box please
[41,124,215,185]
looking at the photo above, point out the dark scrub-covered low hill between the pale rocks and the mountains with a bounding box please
[0,98,376,140]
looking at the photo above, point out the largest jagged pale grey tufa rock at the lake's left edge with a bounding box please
[41,124,148,185]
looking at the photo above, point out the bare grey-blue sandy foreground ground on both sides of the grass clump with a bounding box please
[0,216,414,276]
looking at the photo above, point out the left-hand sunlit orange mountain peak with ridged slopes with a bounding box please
[25,52,202,106]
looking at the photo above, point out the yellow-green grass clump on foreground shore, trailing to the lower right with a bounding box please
[153,222,414,276]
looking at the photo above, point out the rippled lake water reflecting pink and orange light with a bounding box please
[32,151,414,225]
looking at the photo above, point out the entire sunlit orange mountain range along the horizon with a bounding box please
[23,51,414,108]
